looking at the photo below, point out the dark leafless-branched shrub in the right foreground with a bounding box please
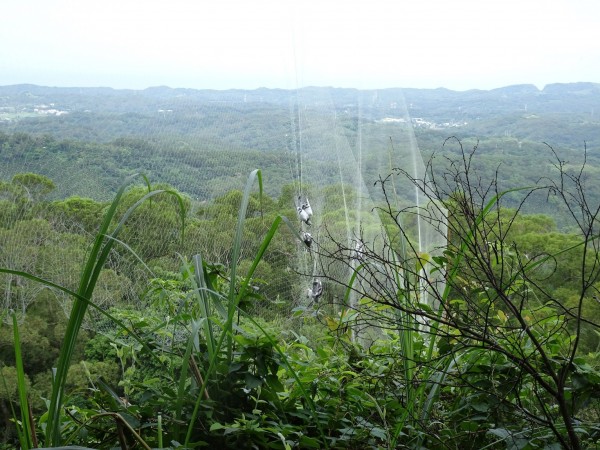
[308,139,600,449]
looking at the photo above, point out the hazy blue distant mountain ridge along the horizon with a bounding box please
[0,82,600,118]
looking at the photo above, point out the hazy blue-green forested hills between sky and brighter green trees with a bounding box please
[0,83,600,210]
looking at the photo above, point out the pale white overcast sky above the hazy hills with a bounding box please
[0,0,600,90]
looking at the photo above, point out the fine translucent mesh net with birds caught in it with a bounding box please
[0,82,445,342]
